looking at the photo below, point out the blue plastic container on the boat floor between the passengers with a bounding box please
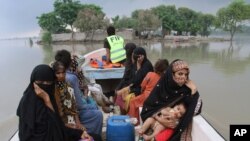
[106,115,135,141]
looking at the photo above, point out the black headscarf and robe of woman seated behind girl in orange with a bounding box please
[130,47,154,96]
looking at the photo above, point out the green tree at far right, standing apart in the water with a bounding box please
[216,0,250,41]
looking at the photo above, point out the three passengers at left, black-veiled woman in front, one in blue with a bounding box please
[17,50,103,141]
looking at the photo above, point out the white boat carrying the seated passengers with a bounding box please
[9,48,225,141]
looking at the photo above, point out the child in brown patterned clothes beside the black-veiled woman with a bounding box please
[52,61,96,141]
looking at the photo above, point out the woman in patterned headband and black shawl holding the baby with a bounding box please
[141,59,202,141]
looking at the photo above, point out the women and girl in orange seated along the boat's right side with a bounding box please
[116,43,202,141]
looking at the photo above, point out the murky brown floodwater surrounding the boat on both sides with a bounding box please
[0,37,250,140]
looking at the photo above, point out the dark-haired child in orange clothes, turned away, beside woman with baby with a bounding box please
[128,59,169,121]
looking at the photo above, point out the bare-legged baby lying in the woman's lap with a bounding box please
[138,102,187,141]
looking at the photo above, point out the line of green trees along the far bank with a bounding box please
[38,0,250,43]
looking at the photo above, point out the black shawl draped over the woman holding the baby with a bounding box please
[141,60,201,140]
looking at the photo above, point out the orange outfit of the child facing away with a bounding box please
[128,72,160,121]
